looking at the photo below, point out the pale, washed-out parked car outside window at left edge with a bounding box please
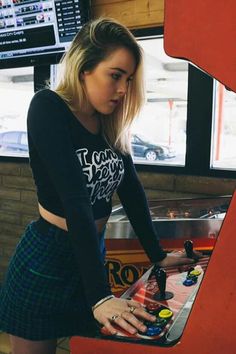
[0,130,28,153]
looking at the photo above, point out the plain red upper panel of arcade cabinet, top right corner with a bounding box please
[164,0,236,91]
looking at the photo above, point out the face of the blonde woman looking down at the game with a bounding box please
[82,48,136,114]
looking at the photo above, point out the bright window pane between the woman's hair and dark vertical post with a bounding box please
[131,36,188,166]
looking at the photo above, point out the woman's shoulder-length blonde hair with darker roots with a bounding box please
[55,18,144,153]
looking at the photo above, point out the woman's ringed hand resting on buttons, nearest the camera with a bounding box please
[93,298,156,334]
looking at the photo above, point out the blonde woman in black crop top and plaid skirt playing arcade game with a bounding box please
[0,19,193,354]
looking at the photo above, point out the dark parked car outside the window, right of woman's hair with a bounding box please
[131,134,175,161]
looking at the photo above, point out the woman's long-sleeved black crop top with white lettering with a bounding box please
[27,90,166,306]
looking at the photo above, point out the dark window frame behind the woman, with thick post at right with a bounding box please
[0,27,236,178]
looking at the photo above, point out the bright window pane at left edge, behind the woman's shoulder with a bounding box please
[0,67,34,157]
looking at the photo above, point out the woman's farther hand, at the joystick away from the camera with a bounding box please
[156,251,203,267]
